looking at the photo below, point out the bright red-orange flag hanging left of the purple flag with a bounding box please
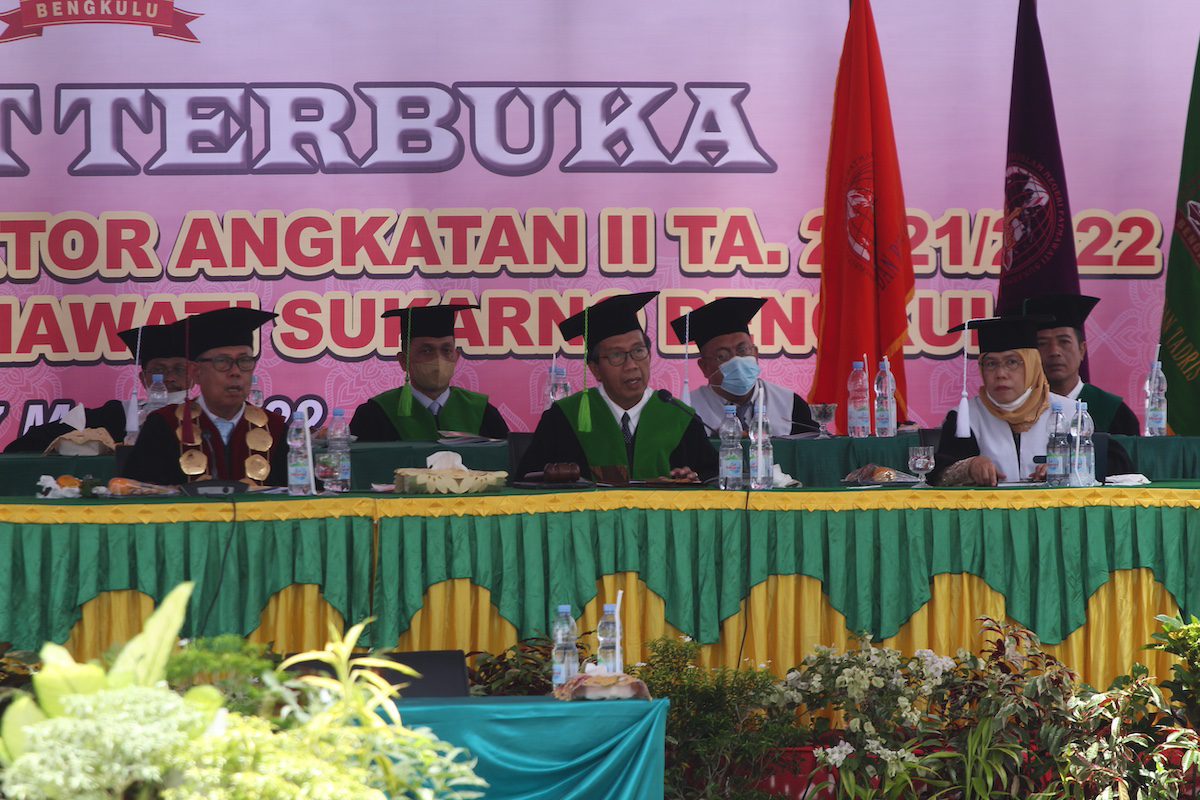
[810,0,913,432]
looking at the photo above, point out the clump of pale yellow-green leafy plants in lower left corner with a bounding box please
[0,584,485,800]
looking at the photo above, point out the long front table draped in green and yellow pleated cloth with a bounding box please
[0,483,1200,685]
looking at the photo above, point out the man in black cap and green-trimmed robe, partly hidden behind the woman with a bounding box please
[1025,294,1140,437]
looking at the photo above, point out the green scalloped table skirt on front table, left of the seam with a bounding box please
[0,503,374,650]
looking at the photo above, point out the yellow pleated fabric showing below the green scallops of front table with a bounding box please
[66,570,1178,687]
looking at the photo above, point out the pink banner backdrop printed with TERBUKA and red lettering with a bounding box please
[0,0,1200,441]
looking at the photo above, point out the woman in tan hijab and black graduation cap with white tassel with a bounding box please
[929,317,1070,486]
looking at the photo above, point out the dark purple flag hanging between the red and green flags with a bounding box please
[996,0,1087,380]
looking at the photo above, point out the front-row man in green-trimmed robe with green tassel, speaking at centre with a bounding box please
[517,291,716,482]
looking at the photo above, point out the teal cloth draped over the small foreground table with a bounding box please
[400,697,668,800]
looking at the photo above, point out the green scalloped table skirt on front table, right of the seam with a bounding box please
[372,492,1200,644]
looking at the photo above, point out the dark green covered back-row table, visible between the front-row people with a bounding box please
[0,433,1200,494]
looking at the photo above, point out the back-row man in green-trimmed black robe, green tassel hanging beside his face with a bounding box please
[350,305,509,441]
